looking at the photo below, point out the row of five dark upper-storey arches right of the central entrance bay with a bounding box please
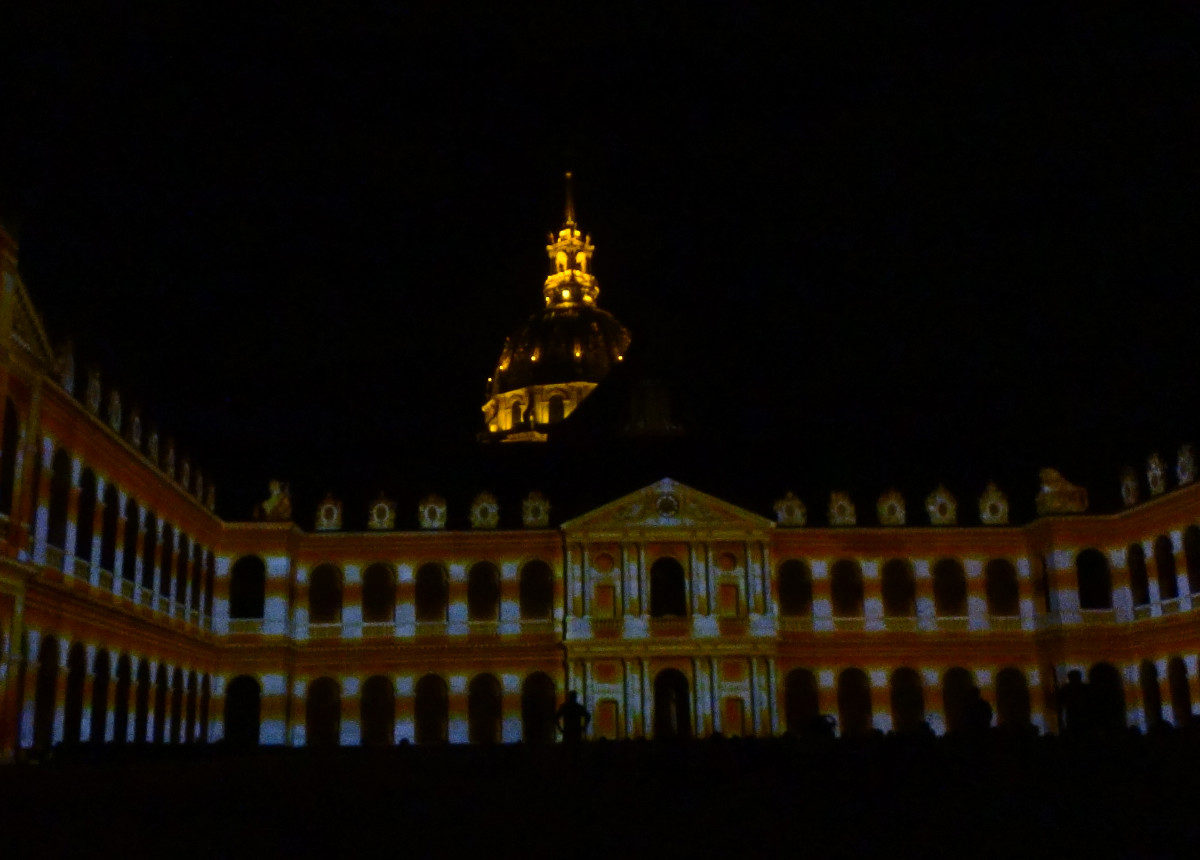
[778,558,1020,618]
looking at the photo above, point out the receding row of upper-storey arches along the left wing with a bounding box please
[33,438,215,617]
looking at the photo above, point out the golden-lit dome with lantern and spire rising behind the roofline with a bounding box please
[482,174,630,441]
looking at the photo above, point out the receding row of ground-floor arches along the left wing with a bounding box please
[31,636,210,752]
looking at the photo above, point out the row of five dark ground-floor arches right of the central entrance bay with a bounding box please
[782,666,1032,738]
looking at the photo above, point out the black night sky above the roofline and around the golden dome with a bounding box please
[0,2,1200,522]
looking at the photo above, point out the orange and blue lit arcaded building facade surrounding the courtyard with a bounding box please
[0,228,1200,759]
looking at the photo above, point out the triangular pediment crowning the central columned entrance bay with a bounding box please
[563,477,775,534]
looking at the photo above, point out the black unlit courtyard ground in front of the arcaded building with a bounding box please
[0,733,1200,858]
